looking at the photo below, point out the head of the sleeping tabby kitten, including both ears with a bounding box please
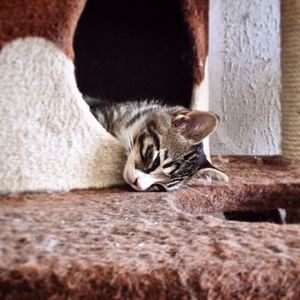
[124,107,227,191]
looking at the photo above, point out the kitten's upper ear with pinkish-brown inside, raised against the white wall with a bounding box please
[172,110,219,143]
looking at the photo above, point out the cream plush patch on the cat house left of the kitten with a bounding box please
[0,37,125,193]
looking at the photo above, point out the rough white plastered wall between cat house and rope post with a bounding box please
[209,0,281,154]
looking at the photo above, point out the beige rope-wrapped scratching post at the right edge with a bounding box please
[281,1,300,162]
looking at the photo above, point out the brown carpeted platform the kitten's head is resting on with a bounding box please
[0,157,300,299]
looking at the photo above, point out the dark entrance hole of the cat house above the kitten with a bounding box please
[74,0,193,107]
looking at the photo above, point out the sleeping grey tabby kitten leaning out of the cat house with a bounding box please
[86,98,227,191]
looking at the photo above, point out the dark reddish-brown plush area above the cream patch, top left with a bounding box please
[0,0,85,58]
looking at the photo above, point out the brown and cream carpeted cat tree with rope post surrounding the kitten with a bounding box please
[0,0,300,299]
